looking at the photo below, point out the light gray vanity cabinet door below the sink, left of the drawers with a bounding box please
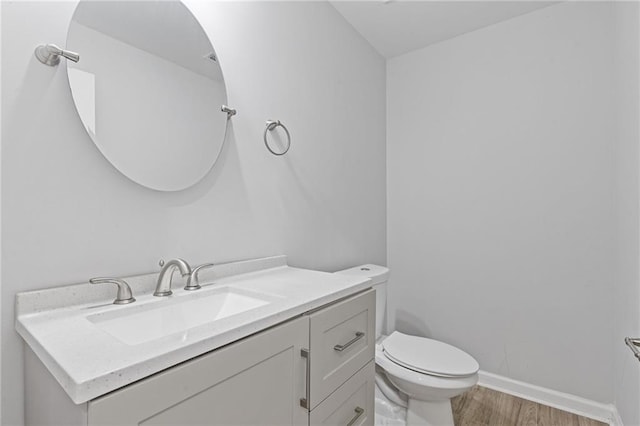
[88,317,309,425]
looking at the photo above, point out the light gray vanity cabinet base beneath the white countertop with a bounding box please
[26,290,375,426]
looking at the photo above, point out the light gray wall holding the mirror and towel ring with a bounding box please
[2,2,386,425]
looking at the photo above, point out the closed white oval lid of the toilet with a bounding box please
[382,331,480,377]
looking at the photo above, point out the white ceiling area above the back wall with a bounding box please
[330,0,555,58]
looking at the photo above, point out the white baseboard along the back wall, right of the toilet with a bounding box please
[478,371,623,426]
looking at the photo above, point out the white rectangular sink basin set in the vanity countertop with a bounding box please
[87,287,277,345]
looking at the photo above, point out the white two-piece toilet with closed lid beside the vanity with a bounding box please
[336,265,480,426]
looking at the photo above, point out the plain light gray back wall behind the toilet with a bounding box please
[387,2,616,403]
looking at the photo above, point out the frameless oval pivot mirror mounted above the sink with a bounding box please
[66,1,227,191]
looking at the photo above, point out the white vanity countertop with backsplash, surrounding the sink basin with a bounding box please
[16,256,371,404]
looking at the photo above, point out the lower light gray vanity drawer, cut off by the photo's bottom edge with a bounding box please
[309,361,375,426]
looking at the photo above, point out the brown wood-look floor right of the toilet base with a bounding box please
[451,386,607,426]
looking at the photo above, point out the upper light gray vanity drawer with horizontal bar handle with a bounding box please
[309,290,376,409]
